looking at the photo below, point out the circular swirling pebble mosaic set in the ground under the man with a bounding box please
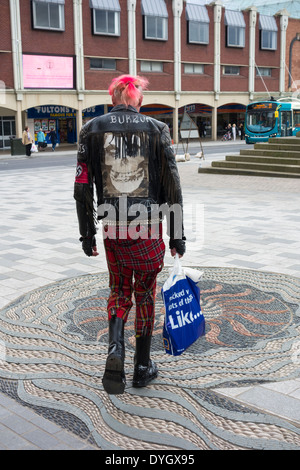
[0,268,300,450]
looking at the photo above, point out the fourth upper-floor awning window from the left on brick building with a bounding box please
[185,0,209,44]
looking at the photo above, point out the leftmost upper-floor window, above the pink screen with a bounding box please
[32,0,65,31]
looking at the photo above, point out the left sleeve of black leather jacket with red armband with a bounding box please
[74,126,96,238]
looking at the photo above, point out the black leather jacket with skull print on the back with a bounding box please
[74,105,184,239]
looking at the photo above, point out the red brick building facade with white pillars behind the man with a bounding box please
[0,0,300,149]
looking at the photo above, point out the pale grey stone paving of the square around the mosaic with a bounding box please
[0,152,300,449]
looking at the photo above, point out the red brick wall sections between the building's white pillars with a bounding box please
[0,0,300,96]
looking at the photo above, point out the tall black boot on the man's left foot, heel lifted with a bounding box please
[102,315,126,395]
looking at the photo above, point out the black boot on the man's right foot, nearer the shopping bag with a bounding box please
[132,336,158,387]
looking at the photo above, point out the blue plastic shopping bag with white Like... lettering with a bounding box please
[161,255,205,356]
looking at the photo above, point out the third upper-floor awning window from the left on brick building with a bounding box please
[142,0,168,41]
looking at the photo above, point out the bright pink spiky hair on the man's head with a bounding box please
[108,75,149,106]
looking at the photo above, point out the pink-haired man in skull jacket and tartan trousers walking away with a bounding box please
[74,75,185,394]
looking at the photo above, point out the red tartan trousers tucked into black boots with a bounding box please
[104,227,165,337]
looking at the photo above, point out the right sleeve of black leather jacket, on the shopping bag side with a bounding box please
[161,124,185,240]
